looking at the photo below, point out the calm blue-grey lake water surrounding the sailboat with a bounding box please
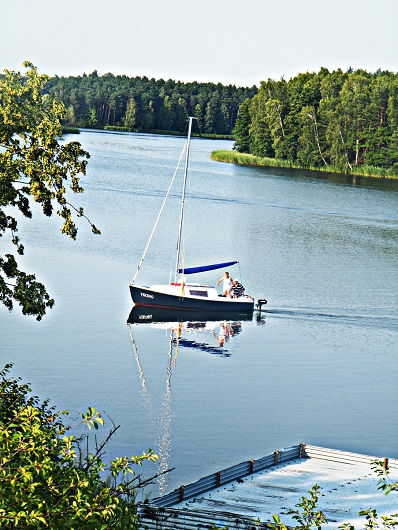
[0,131,398,495]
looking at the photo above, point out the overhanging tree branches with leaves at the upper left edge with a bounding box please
[0,63,100,320]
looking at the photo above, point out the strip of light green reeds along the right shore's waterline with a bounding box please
[211,149,398,179]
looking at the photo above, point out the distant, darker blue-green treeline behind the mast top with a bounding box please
[47,71,258,135]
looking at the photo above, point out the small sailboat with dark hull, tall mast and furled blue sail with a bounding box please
[129,117,254,314]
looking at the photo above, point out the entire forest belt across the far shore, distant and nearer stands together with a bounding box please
[46,68,398,173]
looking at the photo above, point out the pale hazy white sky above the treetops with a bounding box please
[0,0,398,86]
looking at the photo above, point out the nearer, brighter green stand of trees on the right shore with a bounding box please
[234,68,398,172]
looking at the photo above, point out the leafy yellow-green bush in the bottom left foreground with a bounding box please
[0,365,157,530]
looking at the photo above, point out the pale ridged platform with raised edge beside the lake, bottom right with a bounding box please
[139,444,398,530]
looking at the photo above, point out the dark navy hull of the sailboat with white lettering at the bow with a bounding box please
[130,285,254,314]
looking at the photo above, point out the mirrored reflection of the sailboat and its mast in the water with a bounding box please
[127,306,253,495]
